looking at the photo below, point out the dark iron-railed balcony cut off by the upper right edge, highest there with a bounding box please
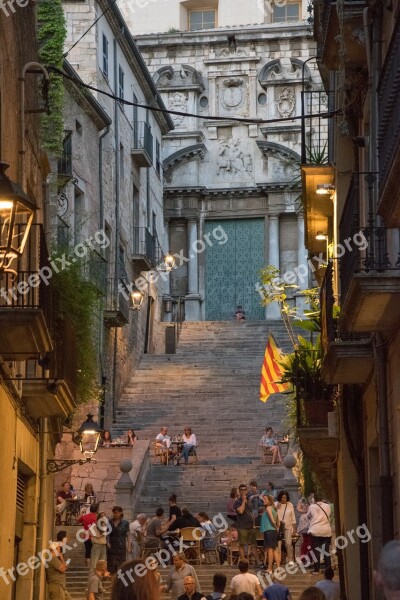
[378,17,400,227]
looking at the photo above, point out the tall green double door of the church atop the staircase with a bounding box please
[205,219,265,321]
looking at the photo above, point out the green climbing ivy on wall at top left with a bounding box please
[37,0,66,158]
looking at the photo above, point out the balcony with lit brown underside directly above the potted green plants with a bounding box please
[320,263,373,385]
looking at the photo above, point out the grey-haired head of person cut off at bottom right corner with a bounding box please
[374,540,400,600]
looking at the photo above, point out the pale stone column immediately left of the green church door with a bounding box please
[185,219,204,321]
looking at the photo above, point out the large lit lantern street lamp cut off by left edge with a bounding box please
[0,162,37,275]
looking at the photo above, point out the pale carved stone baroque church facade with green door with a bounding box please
[124,0,321,321]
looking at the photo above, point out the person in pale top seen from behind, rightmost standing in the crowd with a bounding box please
[307,494,332,575]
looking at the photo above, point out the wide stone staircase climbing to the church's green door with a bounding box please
[112,321,292,516]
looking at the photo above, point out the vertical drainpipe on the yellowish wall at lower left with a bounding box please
[33,417,49,598]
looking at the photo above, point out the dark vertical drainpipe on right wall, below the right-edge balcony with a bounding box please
[374,332,394,544]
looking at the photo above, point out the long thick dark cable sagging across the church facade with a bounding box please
[46,65,342,125]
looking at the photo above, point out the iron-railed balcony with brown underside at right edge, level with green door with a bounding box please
[339,175,400,334]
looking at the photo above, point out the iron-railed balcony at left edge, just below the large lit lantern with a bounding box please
[0,225,53,361]
